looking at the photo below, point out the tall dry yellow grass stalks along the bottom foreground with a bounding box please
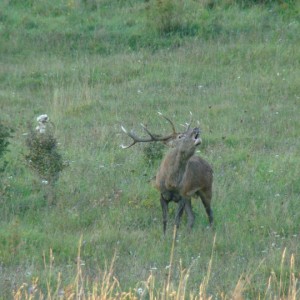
[13,234,300,300]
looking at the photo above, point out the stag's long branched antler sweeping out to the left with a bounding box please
[121,112,179,149]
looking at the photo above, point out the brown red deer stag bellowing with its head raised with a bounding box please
[122,114,213,234]
